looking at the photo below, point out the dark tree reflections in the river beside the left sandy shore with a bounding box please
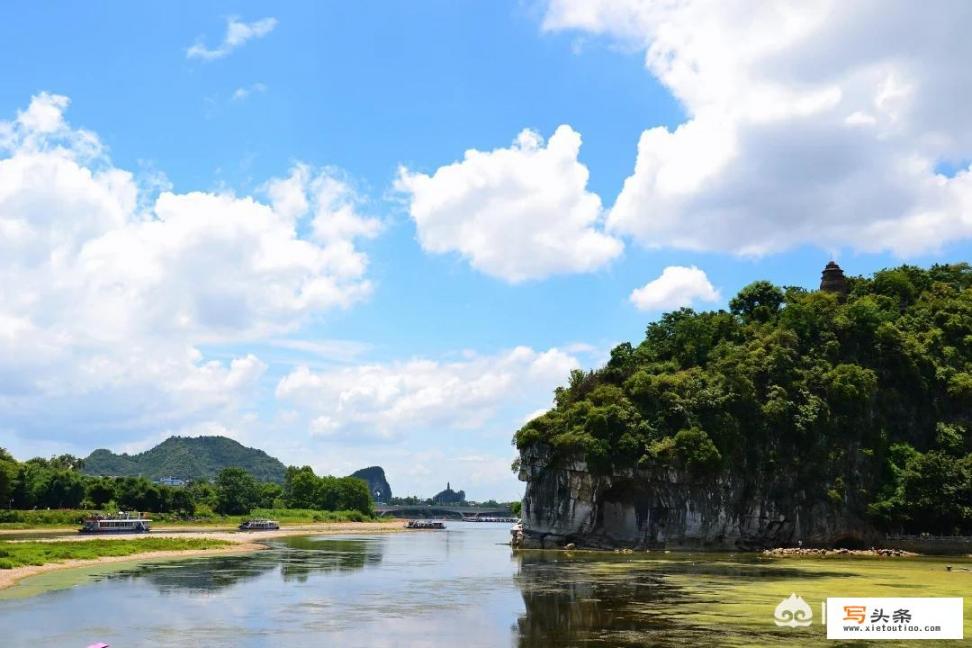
[102,537,384,593]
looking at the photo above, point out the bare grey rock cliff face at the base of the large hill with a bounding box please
[519,447,880,550]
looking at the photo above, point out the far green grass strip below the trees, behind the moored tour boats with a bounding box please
[0,509,377,531]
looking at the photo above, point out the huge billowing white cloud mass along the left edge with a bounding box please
[0,93,380,444]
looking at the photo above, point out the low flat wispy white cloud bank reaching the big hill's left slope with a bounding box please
[276,347,580,441]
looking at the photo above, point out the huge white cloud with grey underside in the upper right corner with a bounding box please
[543,0,972,255]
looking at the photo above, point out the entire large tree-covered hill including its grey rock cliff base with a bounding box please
[515,263,972,550]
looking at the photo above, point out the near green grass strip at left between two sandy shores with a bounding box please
[0,538,232,569]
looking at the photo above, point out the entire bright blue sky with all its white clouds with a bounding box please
[0,0,972,499]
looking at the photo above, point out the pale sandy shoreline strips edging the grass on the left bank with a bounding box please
[0,520,404,590]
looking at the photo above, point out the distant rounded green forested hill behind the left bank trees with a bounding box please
[84,436,286,483]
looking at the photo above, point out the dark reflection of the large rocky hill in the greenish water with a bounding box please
[514,552,853,648]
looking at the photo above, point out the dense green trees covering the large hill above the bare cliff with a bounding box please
[515,264,972,533]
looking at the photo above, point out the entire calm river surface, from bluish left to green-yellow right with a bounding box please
[0,522,972,648]
